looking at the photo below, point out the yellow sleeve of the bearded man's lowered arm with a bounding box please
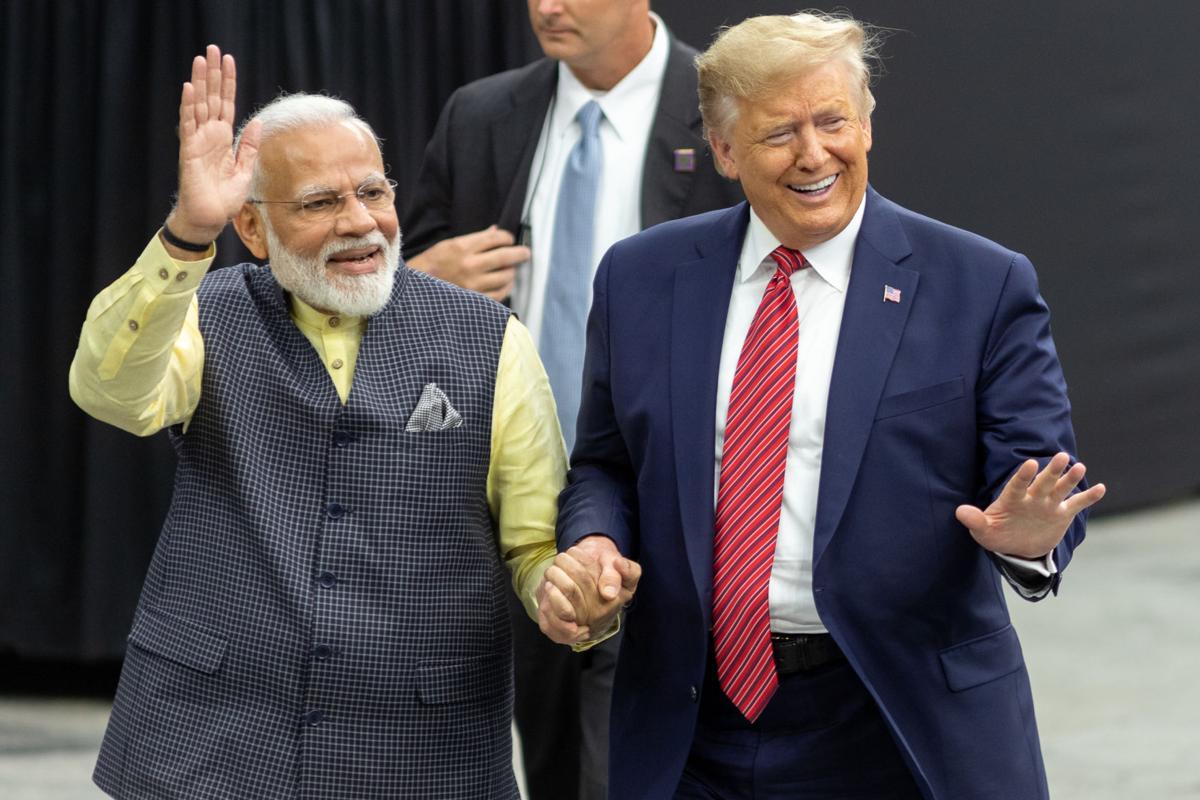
[487,317,566,619]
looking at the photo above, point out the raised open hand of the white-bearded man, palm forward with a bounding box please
[168,44,260,242]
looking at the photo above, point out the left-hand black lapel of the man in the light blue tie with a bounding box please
[492,59,558,233]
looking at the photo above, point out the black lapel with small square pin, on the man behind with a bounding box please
[641,38,707,228]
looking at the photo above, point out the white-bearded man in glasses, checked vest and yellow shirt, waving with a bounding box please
[70,46,576,800]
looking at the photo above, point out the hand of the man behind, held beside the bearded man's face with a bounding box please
[408,225,529,300]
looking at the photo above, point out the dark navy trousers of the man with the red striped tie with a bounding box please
[676,657,922,800]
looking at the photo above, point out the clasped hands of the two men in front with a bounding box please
[538,534,642,644]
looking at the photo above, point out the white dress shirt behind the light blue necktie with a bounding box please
[512,13,670,342]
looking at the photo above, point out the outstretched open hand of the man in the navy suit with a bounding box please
[954,452,1105,559]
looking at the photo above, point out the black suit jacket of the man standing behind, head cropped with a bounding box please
[403,40,742,257]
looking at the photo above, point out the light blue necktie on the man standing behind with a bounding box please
[538,100,604,451]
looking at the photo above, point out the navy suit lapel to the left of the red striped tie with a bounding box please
[671,203,750,614]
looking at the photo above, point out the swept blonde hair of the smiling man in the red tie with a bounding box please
[696,11,881,139]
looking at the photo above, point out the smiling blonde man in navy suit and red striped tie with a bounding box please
[541,13,1104,800]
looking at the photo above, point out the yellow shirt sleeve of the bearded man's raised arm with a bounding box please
[68,227,216,437]
